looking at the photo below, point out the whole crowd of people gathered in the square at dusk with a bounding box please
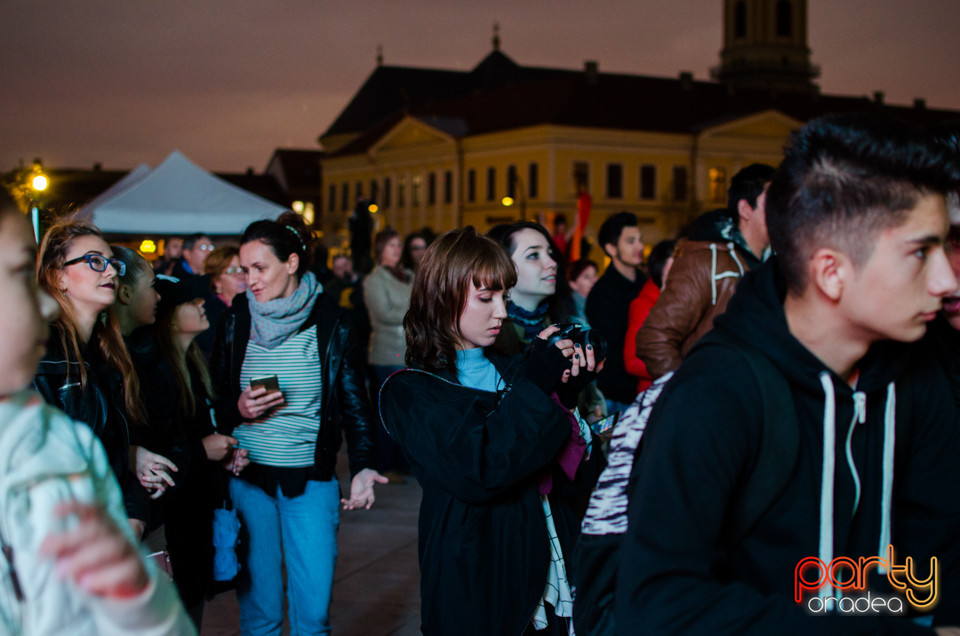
[0,116,960,636]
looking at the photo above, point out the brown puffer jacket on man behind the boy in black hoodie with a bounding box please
[637,239,749,379]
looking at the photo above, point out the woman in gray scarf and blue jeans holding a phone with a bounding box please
[211,212,386,634]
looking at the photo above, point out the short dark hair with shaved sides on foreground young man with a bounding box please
[766,115,960,292]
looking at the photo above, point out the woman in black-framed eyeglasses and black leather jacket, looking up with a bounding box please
[34,221,149,538]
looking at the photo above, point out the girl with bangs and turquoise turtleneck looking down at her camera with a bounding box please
[380,227,594,635]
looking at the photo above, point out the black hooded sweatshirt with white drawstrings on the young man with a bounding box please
[616,259,960,634]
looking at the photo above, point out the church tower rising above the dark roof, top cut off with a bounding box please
[711,0,820,93]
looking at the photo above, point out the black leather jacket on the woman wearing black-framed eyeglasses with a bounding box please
[33,325,150,522]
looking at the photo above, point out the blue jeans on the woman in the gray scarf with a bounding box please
[230,479,340,636]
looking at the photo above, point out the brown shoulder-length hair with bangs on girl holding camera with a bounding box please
[403,226,517,377]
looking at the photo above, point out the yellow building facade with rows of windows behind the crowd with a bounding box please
[322,111,801,250]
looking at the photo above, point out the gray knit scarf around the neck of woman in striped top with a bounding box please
[247,272,323,349]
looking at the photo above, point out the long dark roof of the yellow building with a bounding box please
[325,51,960,156]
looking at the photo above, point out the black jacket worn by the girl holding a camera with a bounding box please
[380,356,576,636]
